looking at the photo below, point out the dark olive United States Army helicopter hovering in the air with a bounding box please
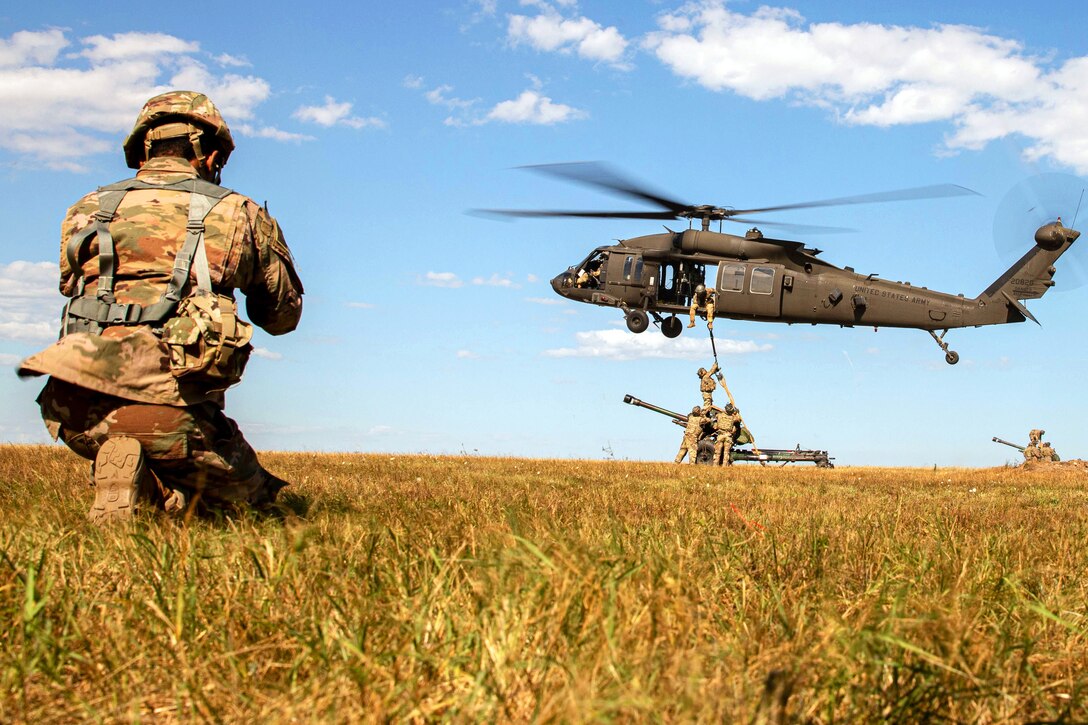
[485,162,1080,365]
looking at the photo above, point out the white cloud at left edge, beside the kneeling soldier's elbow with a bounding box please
[0,261,64,343]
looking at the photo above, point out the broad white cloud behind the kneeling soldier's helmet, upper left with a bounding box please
[0,28,376,171]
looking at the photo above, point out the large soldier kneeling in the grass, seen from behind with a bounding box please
[18,90,302,523]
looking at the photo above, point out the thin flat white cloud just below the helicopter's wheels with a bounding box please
[544,330,772,360]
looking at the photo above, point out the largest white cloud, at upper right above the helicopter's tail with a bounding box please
[642,0,1088,172]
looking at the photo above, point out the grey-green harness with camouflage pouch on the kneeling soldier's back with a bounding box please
[61,179,254,388]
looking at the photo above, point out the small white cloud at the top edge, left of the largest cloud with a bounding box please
[507,3,628,67]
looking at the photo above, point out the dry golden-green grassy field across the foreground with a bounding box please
[0,446,1088,723]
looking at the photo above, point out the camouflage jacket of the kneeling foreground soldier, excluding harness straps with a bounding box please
[18,158,302,406]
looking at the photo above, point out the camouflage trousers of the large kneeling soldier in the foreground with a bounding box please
[38,378,286,505]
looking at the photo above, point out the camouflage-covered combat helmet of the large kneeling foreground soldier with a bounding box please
[124,90,234,169]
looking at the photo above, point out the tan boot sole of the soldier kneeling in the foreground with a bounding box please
[87,438,151,524]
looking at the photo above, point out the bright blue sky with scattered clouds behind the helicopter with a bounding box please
[0,0,1088,466]
